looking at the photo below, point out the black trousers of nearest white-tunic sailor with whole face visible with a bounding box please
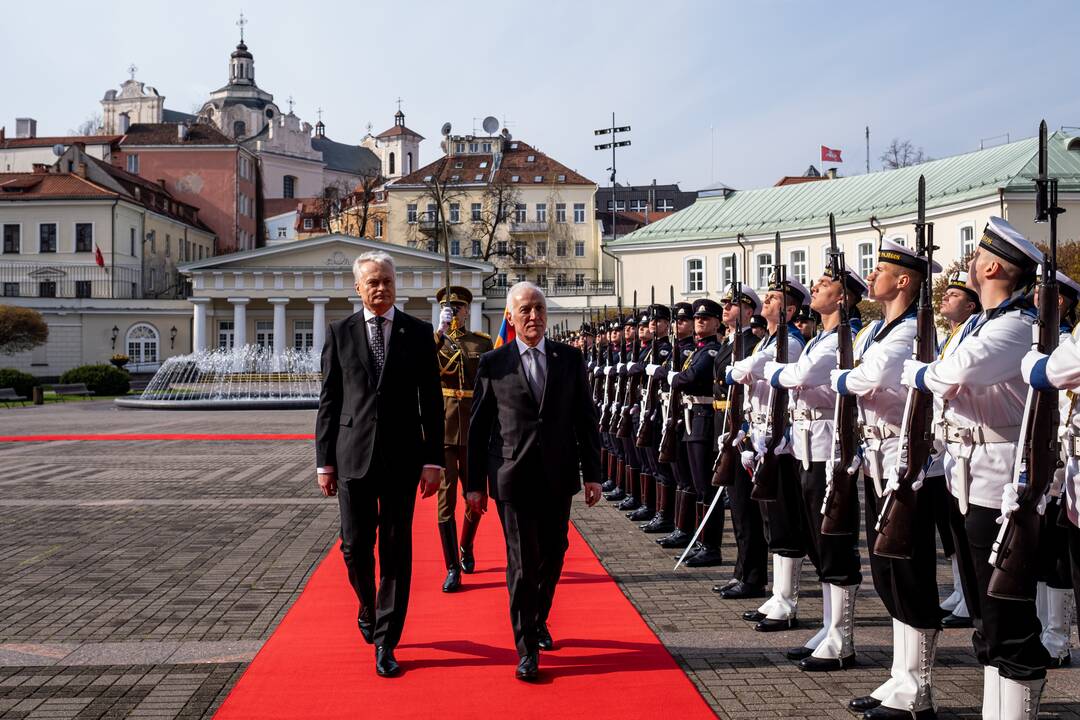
[949,500,1050,680]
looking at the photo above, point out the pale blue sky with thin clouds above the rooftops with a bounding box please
[8,0,1080,189]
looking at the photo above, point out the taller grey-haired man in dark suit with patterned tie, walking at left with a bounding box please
[315,253,443,677]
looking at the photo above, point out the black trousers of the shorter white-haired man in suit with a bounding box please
[496,495,572,656]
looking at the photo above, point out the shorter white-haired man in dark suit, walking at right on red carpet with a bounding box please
[465,283,600,680]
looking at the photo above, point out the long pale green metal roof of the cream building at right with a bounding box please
[610,132,1080,252]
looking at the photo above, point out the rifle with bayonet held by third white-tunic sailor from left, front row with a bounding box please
[821,213,859,535]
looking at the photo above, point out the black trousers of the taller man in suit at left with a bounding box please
[338,458,420,648]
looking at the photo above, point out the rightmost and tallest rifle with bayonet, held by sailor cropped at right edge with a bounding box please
[987,120,1065,600]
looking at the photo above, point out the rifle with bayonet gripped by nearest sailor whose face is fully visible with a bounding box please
[874,175,941,560]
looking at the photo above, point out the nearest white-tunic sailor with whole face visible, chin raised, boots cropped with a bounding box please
[903,217,1050,720]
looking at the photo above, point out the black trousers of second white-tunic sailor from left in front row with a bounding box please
[796,460,863,586]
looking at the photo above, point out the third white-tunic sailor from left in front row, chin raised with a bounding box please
[831,240,941,718]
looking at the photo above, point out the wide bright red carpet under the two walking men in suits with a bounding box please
[210,498,715,720]
